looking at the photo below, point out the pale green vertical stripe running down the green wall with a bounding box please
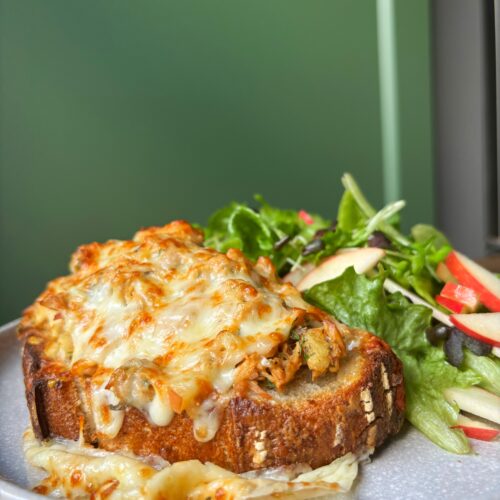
[377,0,401,203]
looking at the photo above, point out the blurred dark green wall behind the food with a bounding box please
[0,0,433,323]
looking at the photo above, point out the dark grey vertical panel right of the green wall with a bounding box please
[433,0,495,257]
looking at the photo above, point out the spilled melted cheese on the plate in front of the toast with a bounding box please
[24,430,358,500]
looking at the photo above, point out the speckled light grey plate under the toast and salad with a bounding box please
[0,322,500,500]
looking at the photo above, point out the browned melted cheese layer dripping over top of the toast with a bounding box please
[20,221,340,441]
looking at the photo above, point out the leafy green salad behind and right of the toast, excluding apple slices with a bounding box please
[204,174,500,453]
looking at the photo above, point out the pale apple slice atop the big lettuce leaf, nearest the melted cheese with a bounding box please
[297,248,385,291]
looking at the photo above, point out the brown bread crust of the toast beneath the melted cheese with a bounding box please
[23,331,404,473]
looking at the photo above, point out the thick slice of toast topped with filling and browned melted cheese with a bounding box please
[19,221,404,498]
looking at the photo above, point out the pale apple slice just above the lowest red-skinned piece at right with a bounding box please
[444,387,500,424]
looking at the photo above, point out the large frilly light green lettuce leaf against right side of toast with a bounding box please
[305,267,482,453]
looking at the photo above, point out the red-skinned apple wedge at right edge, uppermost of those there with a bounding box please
[446,250,500,312]
